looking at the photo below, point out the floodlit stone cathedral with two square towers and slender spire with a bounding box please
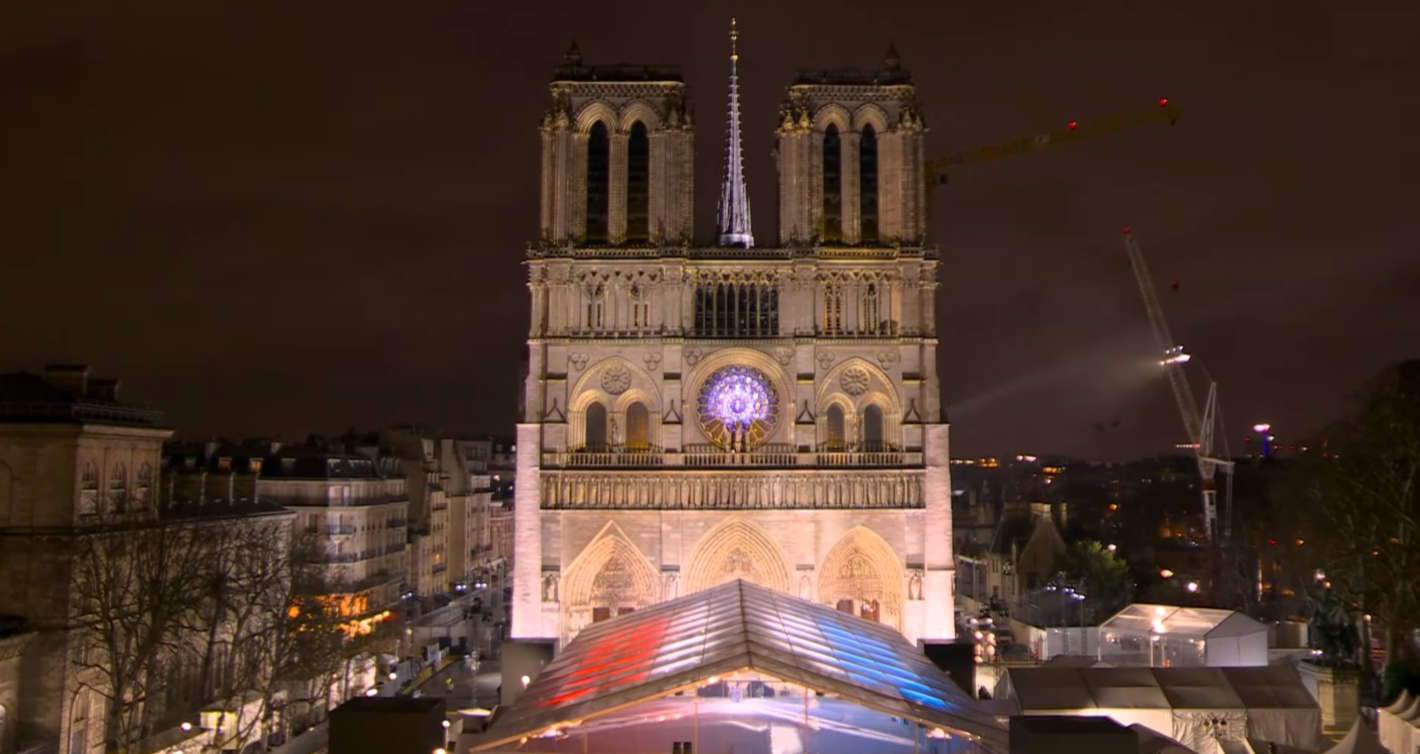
[511,26,953,643]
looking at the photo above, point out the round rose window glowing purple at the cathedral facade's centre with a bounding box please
[699,366,780,450]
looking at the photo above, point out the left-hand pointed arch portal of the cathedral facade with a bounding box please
[562,523,660,640]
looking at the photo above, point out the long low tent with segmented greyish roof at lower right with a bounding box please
[997,666,1323,754]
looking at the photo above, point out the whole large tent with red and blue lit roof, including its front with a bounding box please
[474,579,1007,754]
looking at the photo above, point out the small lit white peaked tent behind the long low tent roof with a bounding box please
[1099,603,1268,667]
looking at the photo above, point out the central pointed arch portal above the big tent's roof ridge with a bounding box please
[682,518,791,594]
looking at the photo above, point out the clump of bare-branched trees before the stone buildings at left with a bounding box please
[71,514,386,753]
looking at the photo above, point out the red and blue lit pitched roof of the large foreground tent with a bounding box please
[481,581,1005,750]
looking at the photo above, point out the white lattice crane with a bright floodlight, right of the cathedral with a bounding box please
[1123,227,1233,542]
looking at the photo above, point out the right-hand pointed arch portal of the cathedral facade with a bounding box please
[818,527,906,630]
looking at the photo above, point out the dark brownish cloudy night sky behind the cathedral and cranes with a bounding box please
[0,0,1420,457]
